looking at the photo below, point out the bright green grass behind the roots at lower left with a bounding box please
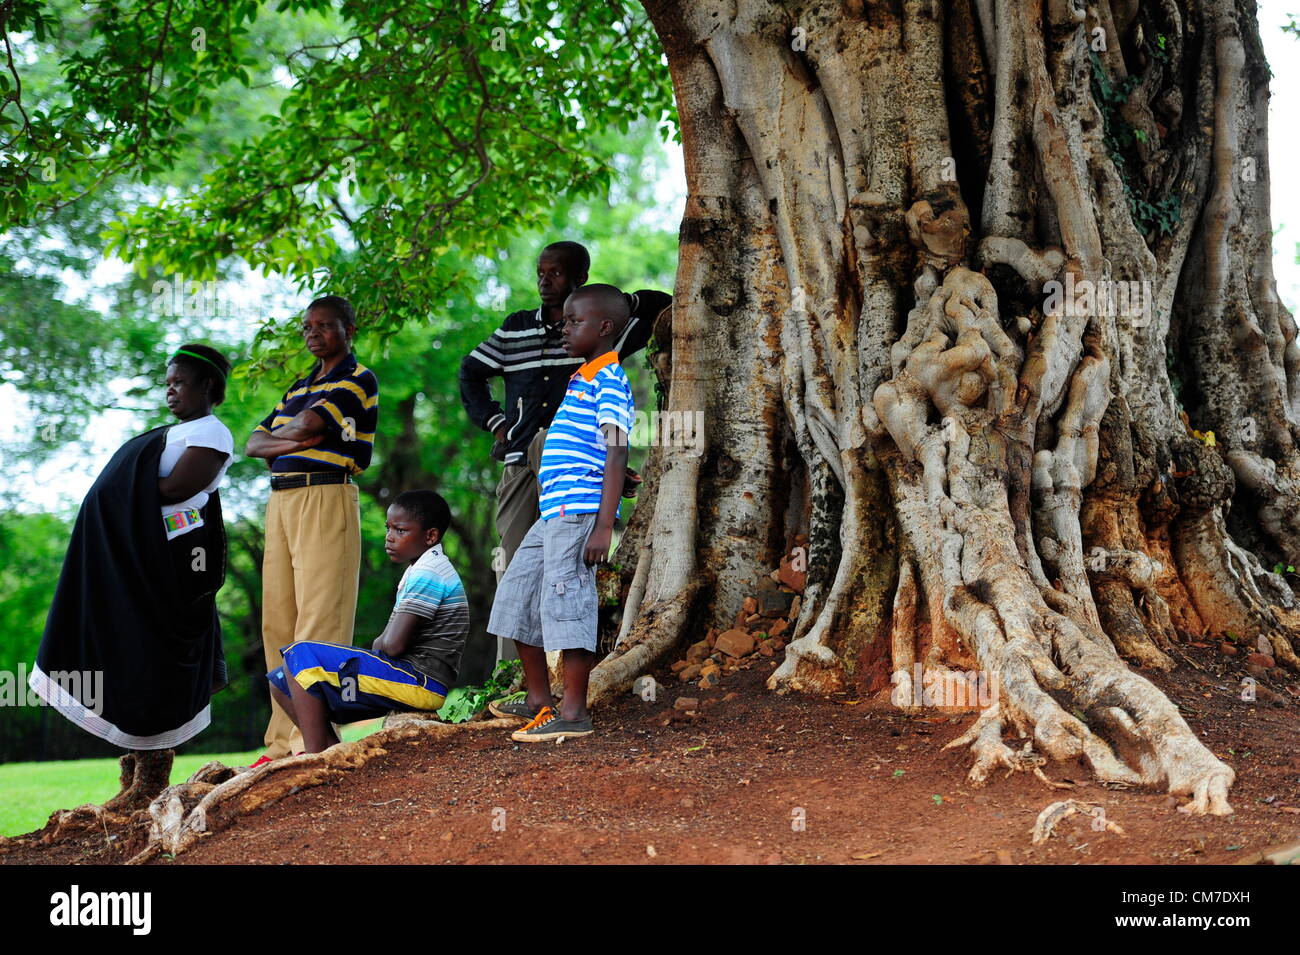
[0,720,380,835]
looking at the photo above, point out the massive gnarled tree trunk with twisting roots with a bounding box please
[593,0,1300,813]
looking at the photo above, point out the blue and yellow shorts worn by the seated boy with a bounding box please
[267,641,447,722]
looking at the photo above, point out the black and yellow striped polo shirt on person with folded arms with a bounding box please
[257,352,380,474]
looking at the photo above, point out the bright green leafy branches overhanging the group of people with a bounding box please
[0,0,672,360]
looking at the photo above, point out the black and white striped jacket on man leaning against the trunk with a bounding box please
[460,288,672,464]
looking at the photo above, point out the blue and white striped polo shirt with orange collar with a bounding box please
[537,351,636,521]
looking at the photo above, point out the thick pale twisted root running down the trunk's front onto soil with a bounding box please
[875,268,1234,815]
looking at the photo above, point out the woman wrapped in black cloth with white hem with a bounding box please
[30,344,234,811]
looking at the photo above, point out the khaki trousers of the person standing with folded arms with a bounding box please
[261,485,361,759]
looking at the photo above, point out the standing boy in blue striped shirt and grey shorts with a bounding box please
[488,285,634,743]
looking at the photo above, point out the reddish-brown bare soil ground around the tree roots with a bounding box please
[0,650,1300,865]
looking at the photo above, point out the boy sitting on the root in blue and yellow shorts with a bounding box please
[267,491,469,752]
